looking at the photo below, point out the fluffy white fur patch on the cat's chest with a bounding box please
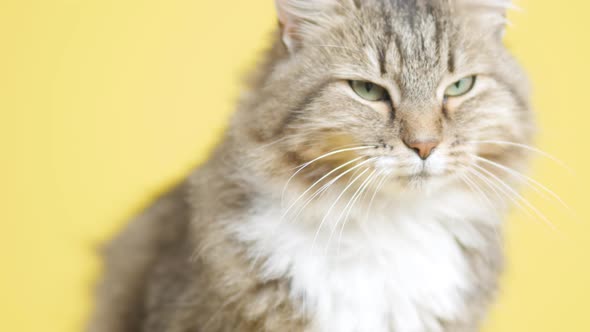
[239,188,500,332]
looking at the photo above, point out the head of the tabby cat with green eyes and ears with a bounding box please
[234,0,533,197]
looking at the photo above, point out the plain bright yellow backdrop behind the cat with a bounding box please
[0,0,590,332]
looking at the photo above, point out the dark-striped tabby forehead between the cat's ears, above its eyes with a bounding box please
[332,0,454,93]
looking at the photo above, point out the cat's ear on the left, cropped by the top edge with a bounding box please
[275,0,340,52]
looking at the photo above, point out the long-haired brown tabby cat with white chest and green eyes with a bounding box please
[90,0,534,332]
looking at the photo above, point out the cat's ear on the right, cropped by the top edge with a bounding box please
[455,0,518,38]
